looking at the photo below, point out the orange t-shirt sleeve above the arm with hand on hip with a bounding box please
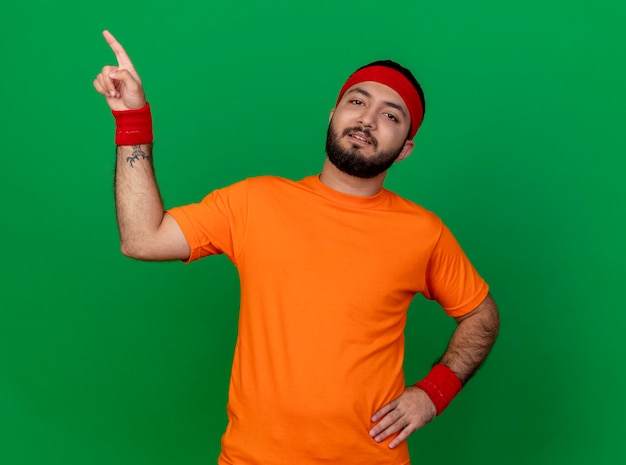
[424,224,489,317]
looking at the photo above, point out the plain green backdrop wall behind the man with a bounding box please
[0,0,626,465]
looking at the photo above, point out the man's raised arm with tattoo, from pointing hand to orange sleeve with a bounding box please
[94,31,190,260]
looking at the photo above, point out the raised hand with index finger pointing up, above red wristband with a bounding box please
[93,31,146,110]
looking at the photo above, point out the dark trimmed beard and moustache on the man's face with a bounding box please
[326,121,404,179]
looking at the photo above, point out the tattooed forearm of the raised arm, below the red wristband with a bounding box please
[115,144,163,257]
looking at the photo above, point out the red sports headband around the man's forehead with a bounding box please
[337,66,424,139]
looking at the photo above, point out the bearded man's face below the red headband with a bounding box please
[326,81,413,178]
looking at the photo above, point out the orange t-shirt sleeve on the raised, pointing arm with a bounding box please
[167,181,248,264]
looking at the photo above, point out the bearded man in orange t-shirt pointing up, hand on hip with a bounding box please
[94,31,499,465]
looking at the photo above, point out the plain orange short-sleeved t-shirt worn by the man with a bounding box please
[169,176,488,465]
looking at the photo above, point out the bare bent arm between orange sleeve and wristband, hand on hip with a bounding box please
[439,295,500,383]
